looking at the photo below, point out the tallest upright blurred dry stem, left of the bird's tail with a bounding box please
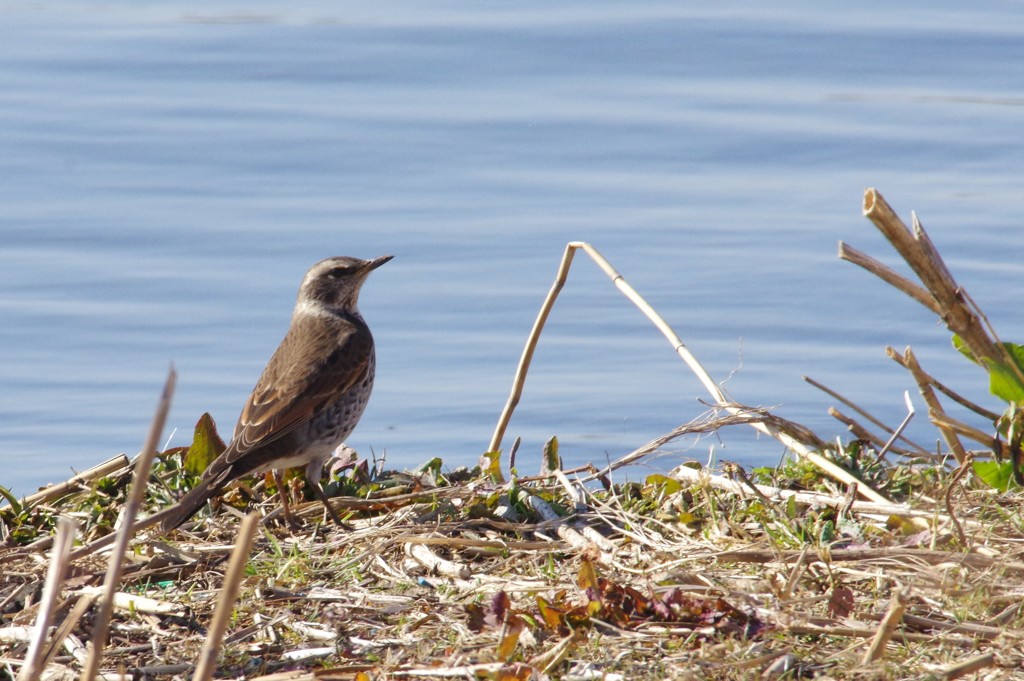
[80,367,177,681]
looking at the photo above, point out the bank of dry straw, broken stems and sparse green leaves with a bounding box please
[0,190,1024,680]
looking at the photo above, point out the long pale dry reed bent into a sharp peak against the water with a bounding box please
[487,242,888,503]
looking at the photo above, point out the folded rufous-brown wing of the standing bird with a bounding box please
[224,317,374,464]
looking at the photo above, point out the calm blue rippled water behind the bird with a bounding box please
[0,1,1024,494]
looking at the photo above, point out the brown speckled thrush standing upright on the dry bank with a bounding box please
[156,255,394,533]
